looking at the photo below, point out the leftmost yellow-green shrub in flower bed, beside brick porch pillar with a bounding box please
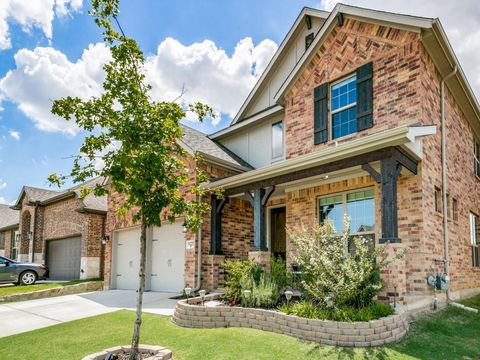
[224,260,257,303]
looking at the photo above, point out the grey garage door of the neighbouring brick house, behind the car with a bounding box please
[47,236,82,280]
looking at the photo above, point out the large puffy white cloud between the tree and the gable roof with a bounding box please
[146,37,277,121]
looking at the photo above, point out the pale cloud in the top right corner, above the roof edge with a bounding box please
[321,0,480,98]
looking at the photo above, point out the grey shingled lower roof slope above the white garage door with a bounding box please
[179,124,253,172]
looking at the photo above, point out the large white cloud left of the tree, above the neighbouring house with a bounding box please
[0,43,110,135]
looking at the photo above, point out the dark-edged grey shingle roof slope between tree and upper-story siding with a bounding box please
[182,124,252,169]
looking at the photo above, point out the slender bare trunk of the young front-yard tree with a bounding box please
[130,215,147,360]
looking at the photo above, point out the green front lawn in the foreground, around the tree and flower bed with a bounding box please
[0,297,480,360]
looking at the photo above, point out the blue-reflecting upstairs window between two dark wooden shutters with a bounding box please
[330,75,357,139]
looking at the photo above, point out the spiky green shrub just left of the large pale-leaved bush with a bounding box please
[241,273,279,309]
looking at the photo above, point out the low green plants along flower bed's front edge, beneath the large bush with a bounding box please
[280,300,395,321]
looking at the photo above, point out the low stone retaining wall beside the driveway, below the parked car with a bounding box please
[0,281,103,303]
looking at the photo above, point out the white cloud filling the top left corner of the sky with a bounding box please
[0,0,82,50]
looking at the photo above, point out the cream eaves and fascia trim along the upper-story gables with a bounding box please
[222,3,480,139]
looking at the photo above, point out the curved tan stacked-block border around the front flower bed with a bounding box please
[172,295,409,347]
